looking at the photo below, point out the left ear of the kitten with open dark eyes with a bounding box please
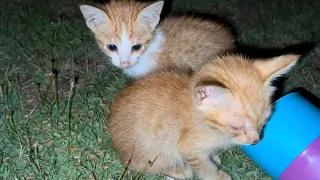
[80,5,110,31]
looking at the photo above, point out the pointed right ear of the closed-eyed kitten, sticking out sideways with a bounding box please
[253,54,300,85]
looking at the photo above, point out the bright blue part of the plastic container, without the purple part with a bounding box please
[242,93,320,179]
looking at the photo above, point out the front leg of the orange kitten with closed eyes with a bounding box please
[187,155,231,180]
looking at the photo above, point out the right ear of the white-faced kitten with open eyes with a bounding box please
[137,1,164,29]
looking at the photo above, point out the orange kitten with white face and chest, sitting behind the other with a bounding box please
[80,0,234,78]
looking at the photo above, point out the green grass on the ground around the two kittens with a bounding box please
[0,0,320,180]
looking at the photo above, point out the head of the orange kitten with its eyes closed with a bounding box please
[193,55,299,145]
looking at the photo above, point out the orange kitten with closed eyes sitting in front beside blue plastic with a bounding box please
[107,54,299,180]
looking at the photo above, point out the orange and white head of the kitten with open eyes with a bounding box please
[80,0,163,68]
